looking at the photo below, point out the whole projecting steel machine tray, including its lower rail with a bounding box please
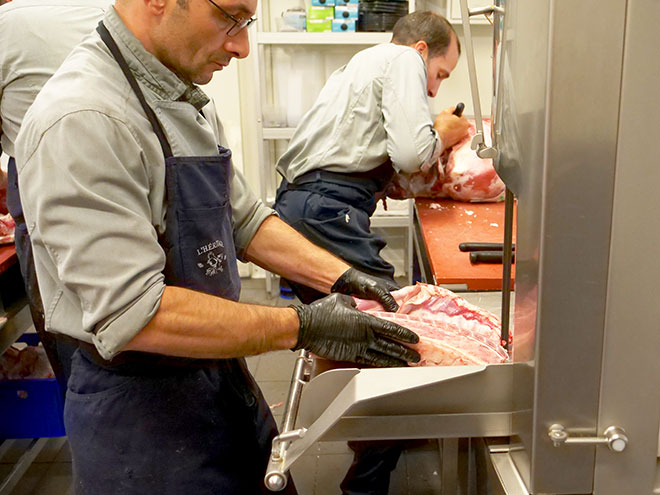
[276,364,512,472]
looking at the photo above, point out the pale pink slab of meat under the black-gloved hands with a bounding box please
[358,284,508,366]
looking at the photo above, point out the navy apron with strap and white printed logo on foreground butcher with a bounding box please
[65,23,295,495]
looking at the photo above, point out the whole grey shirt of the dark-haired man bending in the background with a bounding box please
[277,43,442,182]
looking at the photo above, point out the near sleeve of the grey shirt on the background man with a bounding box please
[383,50,442,173]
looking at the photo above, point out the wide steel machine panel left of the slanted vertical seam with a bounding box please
[497,0,625,494]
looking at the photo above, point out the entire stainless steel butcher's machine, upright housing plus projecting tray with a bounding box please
[267,0,660,495]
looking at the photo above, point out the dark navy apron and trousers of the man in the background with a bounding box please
[274,169,406,495]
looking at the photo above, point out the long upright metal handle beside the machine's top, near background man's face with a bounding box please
[460,0,504,158]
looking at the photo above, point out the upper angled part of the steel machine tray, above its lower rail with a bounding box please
[296,364,512,428]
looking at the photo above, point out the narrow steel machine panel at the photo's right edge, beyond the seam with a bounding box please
[594,0,660,495]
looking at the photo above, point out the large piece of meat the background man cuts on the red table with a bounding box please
[386,119,505,201]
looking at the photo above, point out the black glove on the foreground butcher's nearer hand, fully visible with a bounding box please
[291,294,420,366]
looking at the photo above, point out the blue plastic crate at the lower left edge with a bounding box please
[0,378,66,438]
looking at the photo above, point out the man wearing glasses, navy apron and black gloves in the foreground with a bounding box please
[15,0,419,495]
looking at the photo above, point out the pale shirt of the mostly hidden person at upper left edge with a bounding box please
[0,0,110,156]
